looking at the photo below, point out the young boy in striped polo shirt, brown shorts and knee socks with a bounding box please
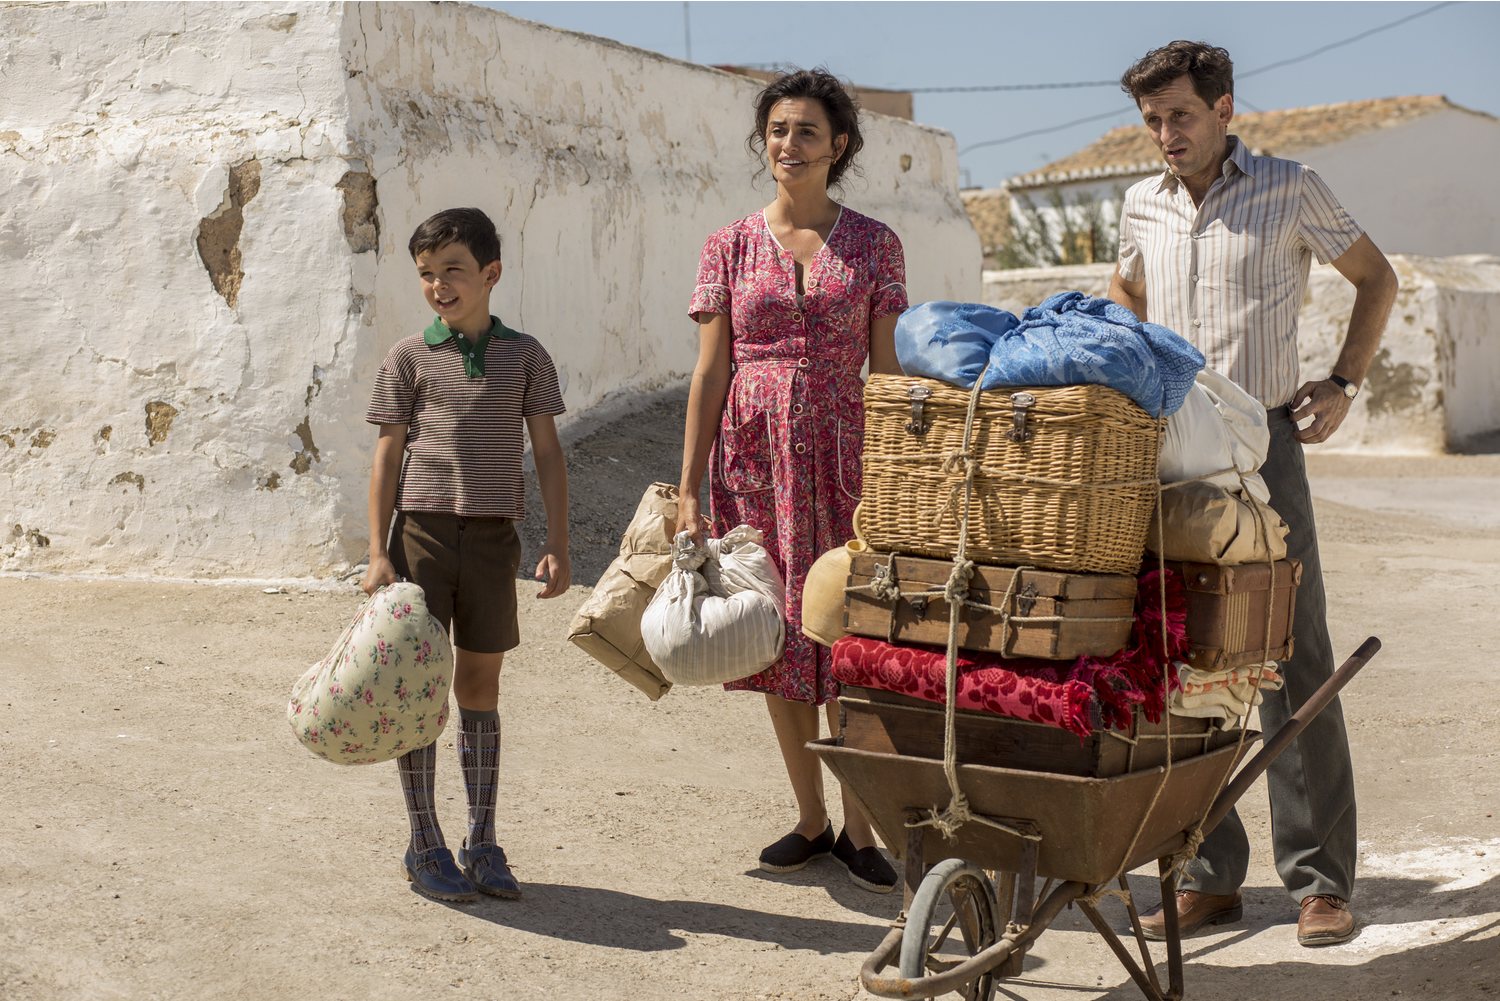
[360,209,572,900]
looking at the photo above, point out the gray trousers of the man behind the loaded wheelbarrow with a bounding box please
[1182,407,1358,903]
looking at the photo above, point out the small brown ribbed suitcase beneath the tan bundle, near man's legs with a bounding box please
[1167,560,1302,671]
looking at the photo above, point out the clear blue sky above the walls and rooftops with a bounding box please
[483,0,1500,186]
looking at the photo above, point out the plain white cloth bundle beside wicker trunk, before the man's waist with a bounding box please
[1158,368,1271,503]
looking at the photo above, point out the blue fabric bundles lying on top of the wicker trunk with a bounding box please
[896,291,1203,417]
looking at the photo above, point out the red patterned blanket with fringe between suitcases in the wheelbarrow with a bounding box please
[833,569,1188,737]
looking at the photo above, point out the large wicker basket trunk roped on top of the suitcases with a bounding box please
[855,375,1164,573]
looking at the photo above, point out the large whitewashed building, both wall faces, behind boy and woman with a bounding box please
[0,3,978,578]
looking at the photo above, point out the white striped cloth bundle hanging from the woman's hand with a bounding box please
[641,525,786,684]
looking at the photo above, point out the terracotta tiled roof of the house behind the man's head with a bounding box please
[1008,95,1488,188]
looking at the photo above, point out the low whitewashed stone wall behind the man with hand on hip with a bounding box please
[981,255,1500,453]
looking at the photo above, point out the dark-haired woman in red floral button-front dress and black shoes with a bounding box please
[678,71,906,893]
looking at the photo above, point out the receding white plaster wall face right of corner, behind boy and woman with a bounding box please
[345,3,980,411]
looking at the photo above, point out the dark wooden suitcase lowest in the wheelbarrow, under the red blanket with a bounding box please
[839,684,1239,779]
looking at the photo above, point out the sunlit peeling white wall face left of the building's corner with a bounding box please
[0,3,359,576]
